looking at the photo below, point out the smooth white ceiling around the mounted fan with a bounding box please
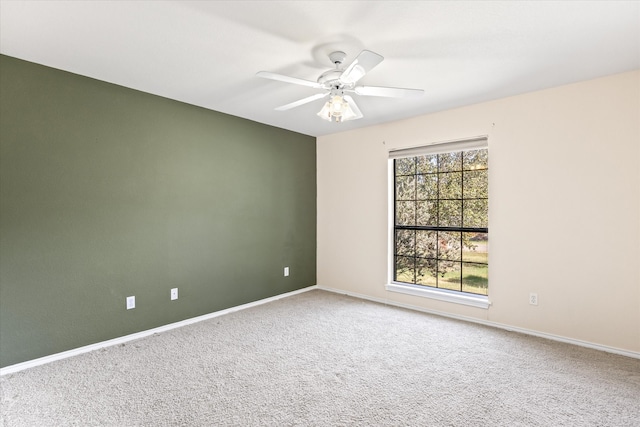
[0,0,640,136]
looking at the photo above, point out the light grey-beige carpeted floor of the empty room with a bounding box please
[0,290,640,427]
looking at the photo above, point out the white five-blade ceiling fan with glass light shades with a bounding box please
[256,50,424,122]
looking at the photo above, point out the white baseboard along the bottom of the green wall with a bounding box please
[0,285,317,376]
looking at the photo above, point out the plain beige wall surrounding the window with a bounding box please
[317,71,640,352]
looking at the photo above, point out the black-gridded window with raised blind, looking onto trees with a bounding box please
[390,138,489,302]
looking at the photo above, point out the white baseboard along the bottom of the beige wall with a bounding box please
[315,286,640,359]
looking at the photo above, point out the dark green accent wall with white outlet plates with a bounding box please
[0,56,316,367]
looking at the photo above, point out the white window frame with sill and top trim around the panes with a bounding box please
[385,136,491,309]
